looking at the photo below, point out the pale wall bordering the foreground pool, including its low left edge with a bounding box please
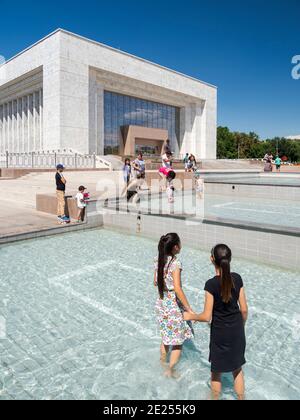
[0,194,300,271]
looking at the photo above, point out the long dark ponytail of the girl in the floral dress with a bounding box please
[157,233,181,299]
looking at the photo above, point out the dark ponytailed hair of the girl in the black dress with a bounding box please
[211,244,235,303]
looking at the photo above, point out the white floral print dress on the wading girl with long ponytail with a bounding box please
[155,257,193,346]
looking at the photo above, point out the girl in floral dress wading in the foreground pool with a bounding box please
[154,233,195,377]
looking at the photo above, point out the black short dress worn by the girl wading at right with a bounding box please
[205,273,246,373]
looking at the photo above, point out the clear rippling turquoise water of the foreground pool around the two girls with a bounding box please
[0,230,300,400]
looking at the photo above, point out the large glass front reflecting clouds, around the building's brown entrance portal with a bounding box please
[104,91,180,155]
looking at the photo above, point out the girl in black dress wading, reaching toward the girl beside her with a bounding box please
[184,245,248,400]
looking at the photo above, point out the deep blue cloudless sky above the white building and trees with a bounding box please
[0,0,300,138]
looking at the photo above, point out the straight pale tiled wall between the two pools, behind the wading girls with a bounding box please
[103,209,300,270]
